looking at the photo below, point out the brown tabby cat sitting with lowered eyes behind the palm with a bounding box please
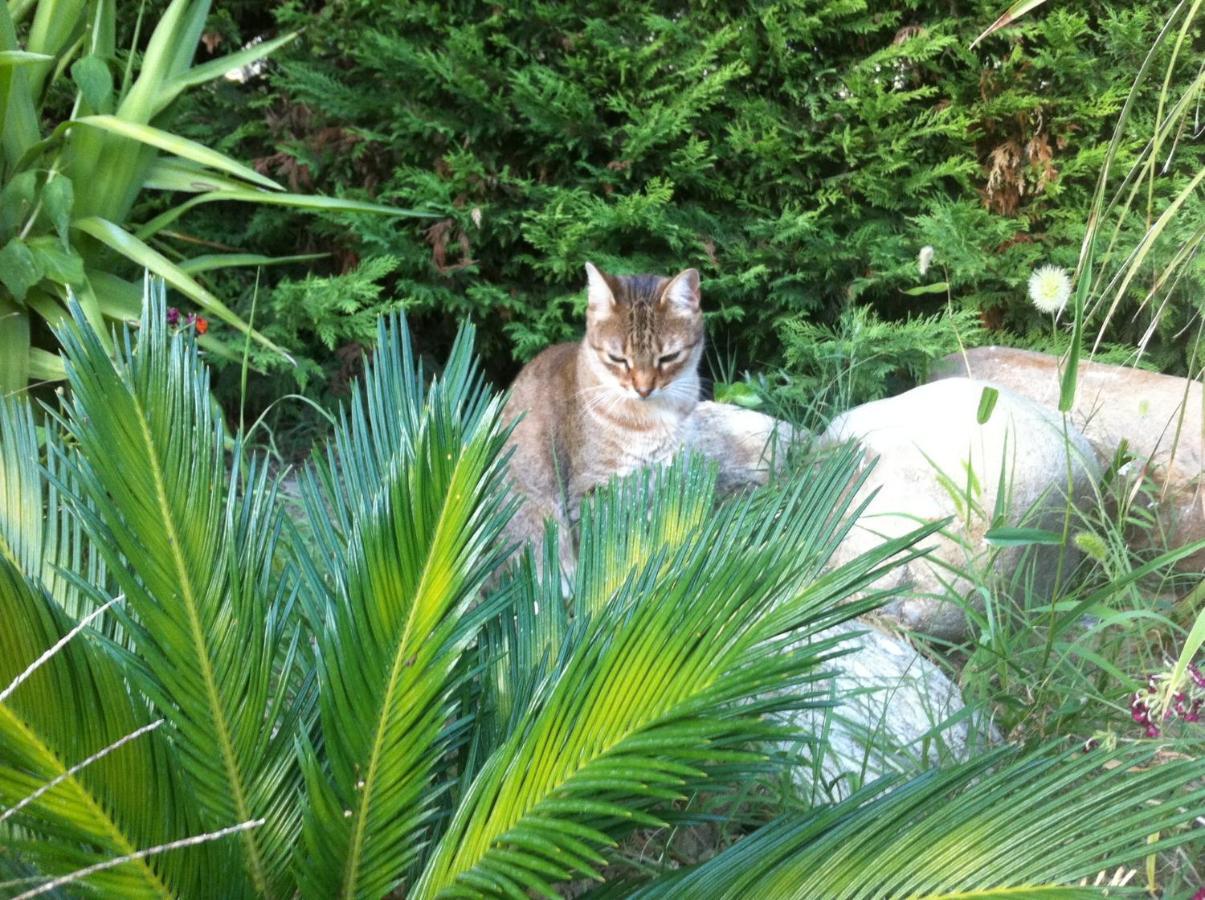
[504,263,703,576]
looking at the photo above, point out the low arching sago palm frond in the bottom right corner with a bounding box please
[636,743,1205,900]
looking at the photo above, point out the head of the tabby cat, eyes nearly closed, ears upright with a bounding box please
[584,263,703,408]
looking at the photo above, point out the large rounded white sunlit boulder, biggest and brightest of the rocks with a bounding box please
[822,378,1099,641]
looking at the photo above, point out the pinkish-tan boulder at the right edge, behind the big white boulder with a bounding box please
[934,347,1205,572]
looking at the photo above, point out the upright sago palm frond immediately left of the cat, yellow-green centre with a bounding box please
[294,319,506,898]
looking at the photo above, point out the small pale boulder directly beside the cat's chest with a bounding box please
[682,400,795,494]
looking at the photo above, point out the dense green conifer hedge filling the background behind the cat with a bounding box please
[157,0,1205,424]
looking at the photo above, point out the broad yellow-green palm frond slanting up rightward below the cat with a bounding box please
[411,451,925,898]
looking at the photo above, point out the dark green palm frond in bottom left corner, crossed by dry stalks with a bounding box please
[0,560,182,896]
